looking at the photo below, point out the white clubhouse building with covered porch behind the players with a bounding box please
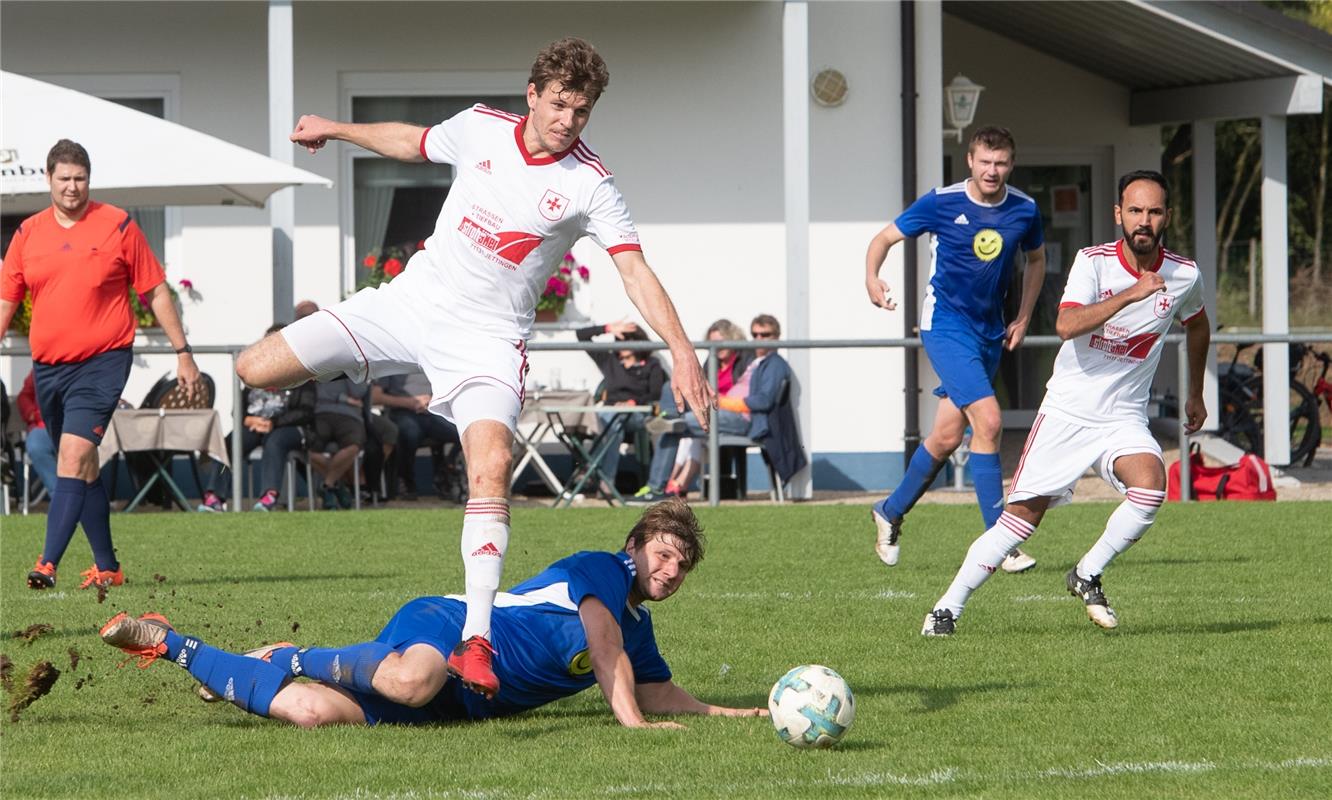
[0,0,1332,489]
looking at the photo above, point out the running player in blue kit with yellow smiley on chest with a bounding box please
[864,128,1046,572]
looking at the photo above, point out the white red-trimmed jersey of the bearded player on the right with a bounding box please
[1040,241,1203,426]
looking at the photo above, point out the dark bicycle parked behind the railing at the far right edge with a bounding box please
[1217,343,1332,466]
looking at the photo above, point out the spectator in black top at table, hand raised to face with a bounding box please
[578,322,667,492]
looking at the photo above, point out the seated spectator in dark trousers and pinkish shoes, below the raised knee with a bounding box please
[198,325,316,511]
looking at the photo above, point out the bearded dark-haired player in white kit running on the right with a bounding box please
[920,170,1212,636]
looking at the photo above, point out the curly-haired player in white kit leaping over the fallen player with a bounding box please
[236,37,715,696]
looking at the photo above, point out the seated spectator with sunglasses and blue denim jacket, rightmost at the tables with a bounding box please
[635,314,805,503]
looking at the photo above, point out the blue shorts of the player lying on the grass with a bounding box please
[352,598,480,725]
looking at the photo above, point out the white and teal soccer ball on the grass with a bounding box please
[767,664,855,748]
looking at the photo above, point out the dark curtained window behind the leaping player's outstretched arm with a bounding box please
[350,95,527,290]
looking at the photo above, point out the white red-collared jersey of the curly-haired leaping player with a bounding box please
[408,104,641,339]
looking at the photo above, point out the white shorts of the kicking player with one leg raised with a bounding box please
[281,273,529,433]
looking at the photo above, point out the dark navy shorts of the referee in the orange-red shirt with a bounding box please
[32,347,133,441]
